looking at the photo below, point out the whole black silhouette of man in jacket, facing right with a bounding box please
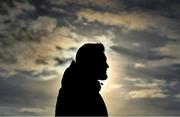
[55,43,109,116]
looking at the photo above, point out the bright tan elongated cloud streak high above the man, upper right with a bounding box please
[77,9,151,30]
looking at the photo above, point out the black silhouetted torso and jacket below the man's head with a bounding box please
[55,61,108,116]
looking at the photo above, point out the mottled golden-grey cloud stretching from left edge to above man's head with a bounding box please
[0,16,113,79]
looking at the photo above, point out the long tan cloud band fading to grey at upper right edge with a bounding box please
[76,9,180,38]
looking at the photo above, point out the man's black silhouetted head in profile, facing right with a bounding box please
[76,43,109,80]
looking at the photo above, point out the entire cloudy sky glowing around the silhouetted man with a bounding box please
[0,0,180,116]
